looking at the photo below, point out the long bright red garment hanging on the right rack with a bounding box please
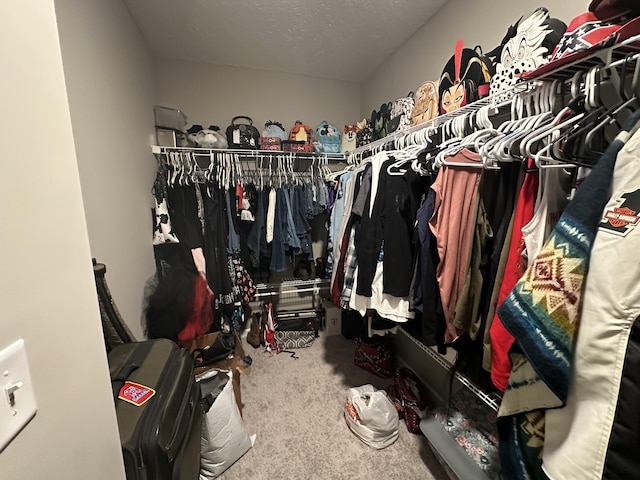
[489,161,538,392]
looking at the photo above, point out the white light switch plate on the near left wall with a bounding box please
[0,339,38,452]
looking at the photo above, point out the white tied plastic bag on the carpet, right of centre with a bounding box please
[344,384,399,449]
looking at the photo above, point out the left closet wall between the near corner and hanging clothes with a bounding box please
[55,0,156,339]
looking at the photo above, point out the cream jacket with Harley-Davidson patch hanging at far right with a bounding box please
[542,118,640,480]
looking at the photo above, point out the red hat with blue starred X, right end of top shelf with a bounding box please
[522,9,640,80]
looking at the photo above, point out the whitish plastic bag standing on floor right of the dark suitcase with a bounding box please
[196,370,256,480]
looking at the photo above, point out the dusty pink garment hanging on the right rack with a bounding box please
[429,149,482,343]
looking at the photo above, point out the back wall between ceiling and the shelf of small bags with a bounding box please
[156,59,360,136]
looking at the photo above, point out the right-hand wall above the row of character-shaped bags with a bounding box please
[361,0,589,118]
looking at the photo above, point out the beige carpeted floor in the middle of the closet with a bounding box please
[219,333,447,480]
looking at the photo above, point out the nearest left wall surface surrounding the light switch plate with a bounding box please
[0,0,124,480]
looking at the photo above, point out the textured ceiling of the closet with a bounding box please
[125,0,447,82]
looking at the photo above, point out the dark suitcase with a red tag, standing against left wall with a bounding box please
[108,339,203,480]
